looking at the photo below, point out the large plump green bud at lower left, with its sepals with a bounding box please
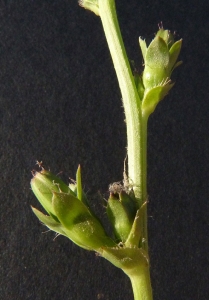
[31,168,116,252]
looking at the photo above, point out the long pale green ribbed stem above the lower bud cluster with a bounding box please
[99,0,148,250]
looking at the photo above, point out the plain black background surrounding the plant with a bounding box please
[0,0,209,300]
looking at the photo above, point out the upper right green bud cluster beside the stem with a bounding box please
[136,28,182,116]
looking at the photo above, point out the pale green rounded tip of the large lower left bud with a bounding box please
[31,169,75,219]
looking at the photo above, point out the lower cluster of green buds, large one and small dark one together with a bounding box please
[31,166,147,270]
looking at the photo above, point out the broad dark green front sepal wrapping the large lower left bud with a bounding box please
[52,193,115,251]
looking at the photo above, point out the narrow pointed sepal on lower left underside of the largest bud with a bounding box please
[31,207,67,236]
